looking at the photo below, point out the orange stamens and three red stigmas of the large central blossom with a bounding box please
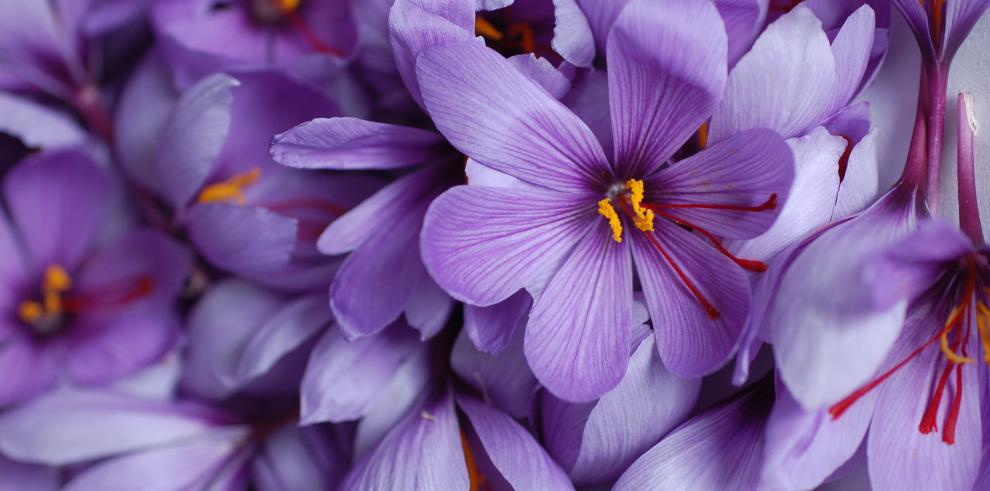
[598,179,777,320]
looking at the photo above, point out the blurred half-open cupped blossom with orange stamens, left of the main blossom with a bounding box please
[117,60,378,290]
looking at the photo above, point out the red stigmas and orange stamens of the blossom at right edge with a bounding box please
[828,260,990,445]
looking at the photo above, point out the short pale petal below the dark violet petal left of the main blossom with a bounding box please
[301,322,418,424]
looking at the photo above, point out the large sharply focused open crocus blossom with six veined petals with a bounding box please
[417,1,793,402]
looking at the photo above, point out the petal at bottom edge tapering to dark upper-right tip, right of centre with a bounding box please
[612,384,773,491]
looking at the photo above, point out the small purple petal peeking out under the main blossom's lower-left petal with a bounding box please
[464,290,533,354]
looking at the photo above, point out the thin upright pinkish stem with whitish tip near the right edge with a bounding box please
[956,92,983,244]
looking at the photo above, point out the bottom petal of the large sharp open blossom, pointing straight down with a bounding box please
[525,225,633,402]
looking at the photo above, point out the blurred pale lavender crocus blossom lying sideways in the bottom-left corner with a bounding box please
[0,390,347,491]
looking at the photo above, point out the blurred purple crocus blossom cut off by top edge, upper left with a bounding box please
[152,0,357,87]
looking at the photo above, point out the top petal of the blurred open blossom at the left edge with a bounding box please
[4,151,110,271]
